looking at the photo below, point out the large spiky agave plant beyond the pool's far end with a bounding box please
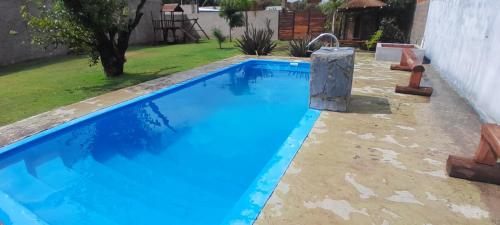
[235,20,277,55]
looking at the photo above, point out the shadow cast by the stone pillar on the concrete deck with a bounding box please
[349,95,392,114]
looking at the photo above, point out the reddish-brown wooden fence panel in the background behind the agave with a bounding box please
[278,9,326,40]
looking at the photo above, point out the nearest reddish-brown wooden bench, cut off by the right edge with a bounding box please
[446,124,500,184]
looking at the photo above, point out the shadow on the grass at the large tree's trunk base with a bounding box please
[73,66,178,93]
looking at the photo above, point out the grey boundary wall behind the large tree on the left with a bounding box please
[0,0,161,66]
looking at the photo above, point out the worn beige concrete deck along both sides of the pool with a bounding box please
[0,53,500,225]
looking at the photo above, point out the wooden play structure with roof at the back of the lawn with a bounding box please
[151,4,210,43]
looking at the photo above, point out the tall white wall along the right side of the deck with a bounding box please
[424,0,500,123]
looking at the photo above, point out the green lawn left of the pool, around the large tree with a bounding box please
[0,41,240,125]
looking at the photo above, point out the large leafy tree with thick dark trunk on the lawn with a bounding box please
[21,0,147,77]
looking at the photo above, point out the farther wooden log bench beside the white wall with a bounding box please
[391,48,433,96]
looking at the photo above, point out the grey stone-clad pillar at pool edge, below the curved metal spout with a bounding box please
[309,47,354,112]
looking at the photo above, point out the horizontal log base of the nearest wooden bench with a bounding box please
[446,155,500,185]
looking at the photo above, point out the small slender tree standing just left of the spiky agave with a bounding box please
[219,0,245,42]
